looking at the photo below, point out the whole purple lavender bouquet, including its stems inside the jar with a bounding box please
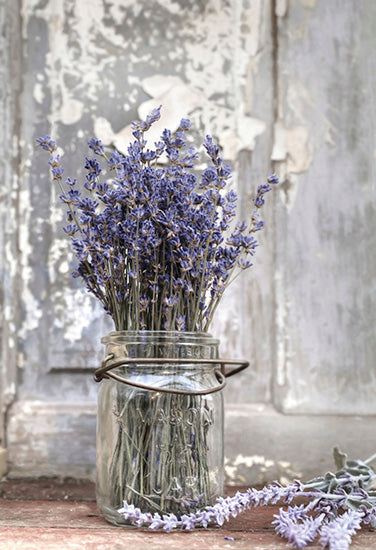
[37,107,278,517]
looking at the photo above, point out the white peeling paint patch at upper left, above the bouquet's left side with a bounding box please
[22,0,127,128]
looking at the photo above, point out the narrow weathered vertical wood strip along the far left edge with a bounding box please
[0,0,22,446]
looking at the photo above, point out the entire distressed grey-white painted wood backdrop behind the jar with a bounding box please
[0,0,376,483]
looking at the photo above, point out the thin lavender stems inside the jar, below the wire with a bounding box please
[110,391,211,513]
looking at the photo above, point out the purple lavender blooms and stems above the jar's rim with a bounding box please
[37,107,278,331]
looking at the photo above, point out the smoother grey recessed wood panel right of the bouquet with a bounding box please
[273,1,376,415]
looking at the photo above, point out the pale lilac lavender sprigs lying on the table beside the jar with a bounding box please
[118,448,376,550]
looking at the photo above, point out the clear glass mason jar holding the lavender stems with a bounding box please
[97,331,224,525]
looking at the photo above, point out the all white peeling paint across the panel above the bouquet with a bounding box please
[22,0,265,168]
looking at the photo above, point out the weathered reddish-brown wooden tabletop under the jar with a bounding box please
[0,480,376,550]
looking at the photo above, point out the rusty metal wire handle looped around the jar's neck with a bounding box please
[94,354,249,395]
